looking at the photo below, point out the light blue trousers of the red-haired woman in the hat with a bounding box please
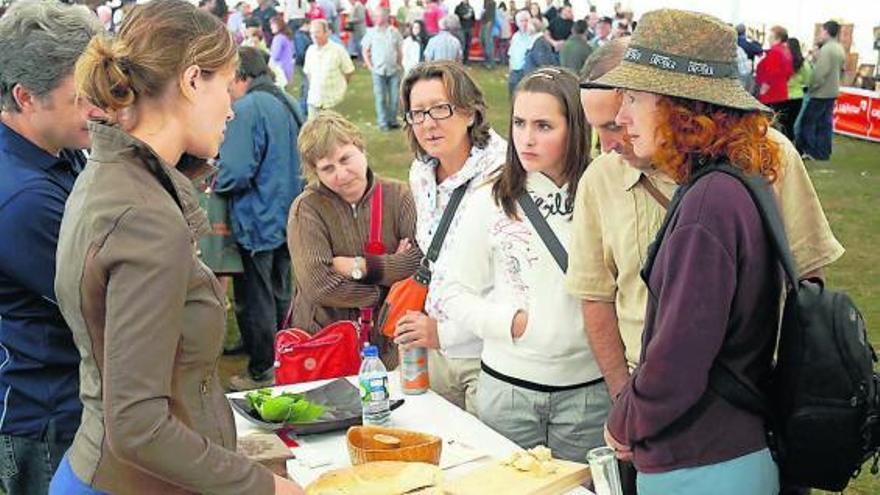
[636,449,779,495]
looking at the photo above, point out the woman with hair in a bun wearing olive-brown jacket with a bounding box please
[50,0,303,495]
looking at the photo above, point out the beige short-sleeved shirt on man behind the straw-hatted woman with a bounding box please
[566,129,844,369]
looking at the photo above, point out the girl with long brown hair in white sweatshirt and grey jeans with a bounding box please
[444,68,609,462]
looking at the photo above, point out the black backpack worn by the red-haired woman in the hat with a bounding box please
[643,163,880,491]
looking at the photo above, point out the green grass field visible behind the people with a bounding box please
[239,67,880,495]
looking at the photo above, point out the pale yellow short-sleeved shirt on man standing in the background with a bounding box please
[303,41,354,108]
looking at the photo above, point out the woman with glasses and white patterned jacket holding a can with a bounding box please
[395,61,507,414]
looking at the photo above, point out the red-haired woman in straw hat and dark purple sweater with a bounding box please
[595,9,781,495]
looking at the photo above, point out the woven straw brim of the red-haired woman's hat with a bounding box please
[580,61,772,112]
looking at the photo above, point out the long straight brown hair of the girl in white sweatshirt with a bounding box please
[492,67,590,220]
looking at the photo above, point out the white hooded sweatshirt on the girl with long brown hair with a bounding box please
[442,172,602,386]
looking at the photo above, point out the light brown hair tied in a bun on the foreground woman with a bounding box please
[74,0,238,111]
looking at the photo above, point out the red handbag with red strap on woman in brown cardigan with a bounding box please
[275,184,385,385]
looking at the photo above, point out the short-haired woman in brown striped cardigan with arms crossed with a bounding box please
[287,111,422,369]
